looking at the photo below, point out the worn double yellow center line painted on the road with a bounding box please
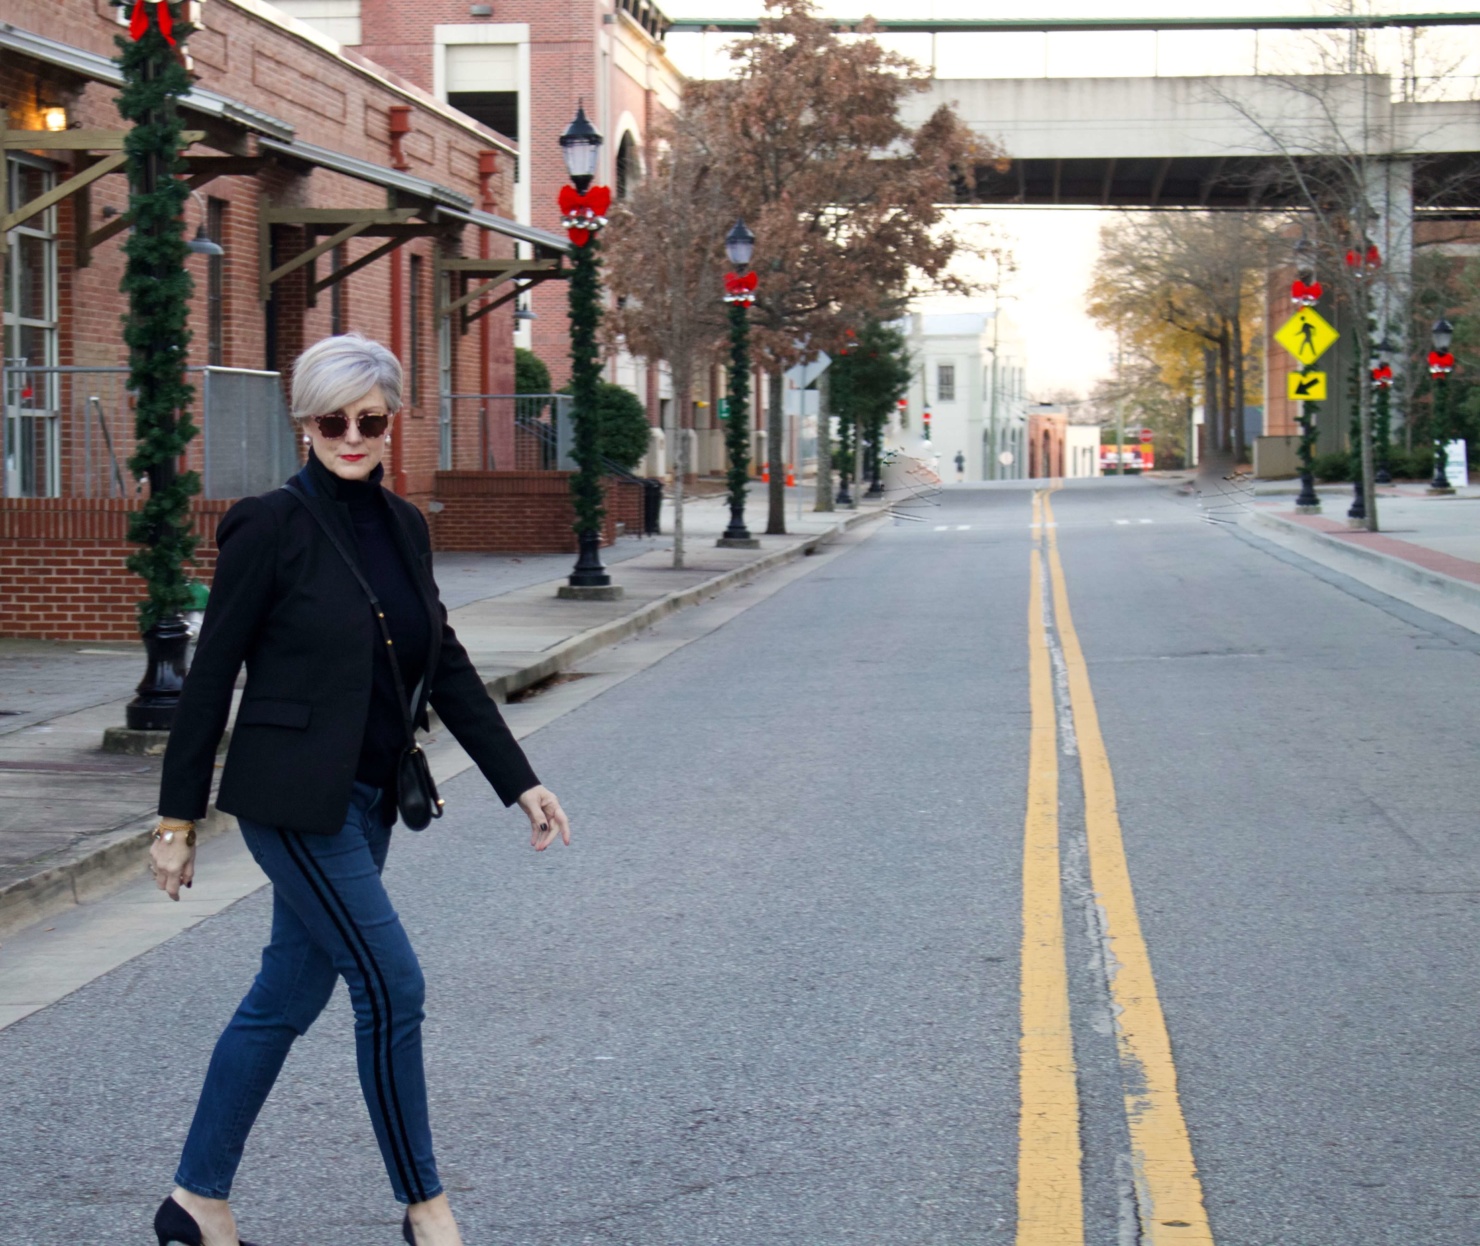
[1017,488,1212,1246]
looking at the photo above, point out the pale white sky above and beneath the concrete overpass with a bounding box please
[659,0,1480,397]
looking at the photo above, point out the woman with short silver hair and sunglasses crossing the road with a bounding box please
[151,334,570,1246]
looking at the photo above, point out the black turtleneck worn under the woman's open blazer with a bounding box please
[308,453,432,799]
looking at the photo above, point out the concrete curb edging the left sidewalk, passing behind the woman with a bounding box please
[0,509,888,938]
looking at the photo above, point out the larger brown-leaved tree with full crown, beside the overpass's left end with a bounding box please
[685,0,992,533]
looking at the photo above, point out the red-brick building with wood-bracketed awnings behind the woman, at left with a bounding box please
[0,0,606,639]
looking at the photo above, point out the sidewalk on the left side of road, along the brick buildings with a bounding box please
[0,484,884,937]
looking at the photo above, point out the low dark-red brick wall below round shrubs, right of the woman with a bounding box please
[431,472,642,553]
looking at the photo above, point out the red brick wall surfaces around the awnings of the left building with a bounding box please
[0,0,523,505]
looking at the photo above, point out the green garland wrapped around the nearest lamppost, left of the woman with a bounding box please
[115,4,200,632]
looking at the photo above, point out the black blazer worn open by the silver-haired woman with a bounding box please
[160,465,539,835]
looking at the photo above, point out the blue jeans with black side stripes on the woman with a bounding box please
[175,783,443,1203]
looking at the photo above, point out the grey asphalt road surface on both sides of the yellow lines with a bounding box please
[0,470,1480,1246]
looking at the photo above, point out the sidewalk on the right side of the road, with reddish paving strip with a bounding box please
[1246,484,1480,626]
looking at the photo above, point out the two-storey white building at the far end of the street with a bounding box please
[889,302,1027,481]
